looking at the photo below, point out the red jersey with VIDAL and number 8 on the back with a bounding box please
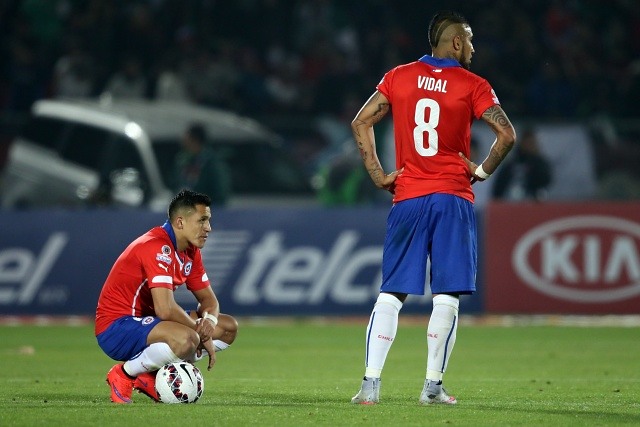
[376,55,500,202]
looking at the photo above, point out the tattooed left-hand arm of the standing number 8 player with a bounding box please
[351,91,402,193]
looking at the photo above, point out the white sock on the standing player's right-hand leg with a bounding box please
[427,295,460,381]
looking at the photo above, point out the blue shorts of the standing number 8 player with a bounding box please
[380,193,478,295]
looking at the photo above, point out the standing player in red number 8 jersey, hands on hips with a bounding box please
[351,12,515,404]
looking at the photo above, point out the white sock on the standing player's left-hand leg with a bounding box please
[364,293,402,378]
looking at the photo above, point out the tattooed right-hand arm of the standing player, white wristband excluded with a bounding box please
[460,105,516,183]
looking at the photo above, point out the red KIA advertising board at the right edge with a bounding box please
[484,202,640,314]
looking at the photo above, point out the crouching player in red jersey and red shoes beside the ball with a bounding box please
[95,190,238,403]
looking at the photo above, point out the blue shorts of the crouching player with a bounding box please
[96,316,161,361]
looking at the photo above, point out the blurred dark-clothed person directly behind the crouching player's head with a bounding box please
[173,123,231,206]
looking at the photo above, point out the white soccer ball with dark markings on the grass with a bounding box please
[156,362,204,403]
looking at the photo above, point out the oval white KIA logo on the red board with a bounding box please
[511,215,640,303]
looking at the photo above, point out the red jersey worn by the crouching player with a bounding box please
[95,223,210,335]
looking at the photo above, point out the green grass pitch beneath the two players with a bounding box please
[0,319,640,427]
